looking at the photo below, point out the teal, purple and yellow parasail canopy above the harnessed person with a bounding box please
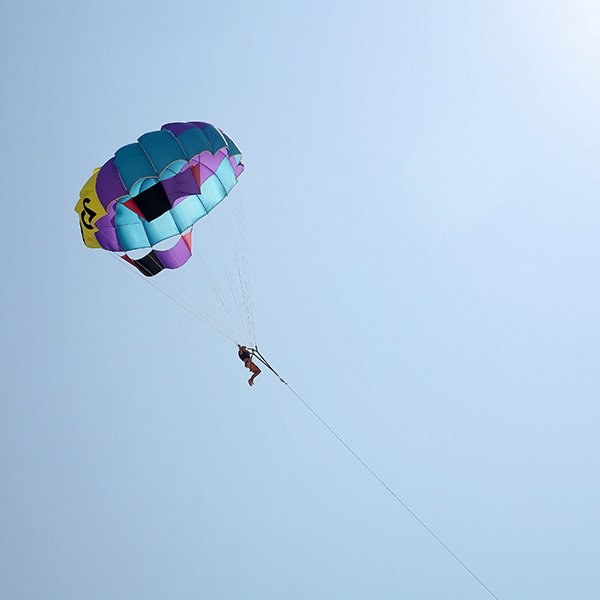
[75,122,244,277]
